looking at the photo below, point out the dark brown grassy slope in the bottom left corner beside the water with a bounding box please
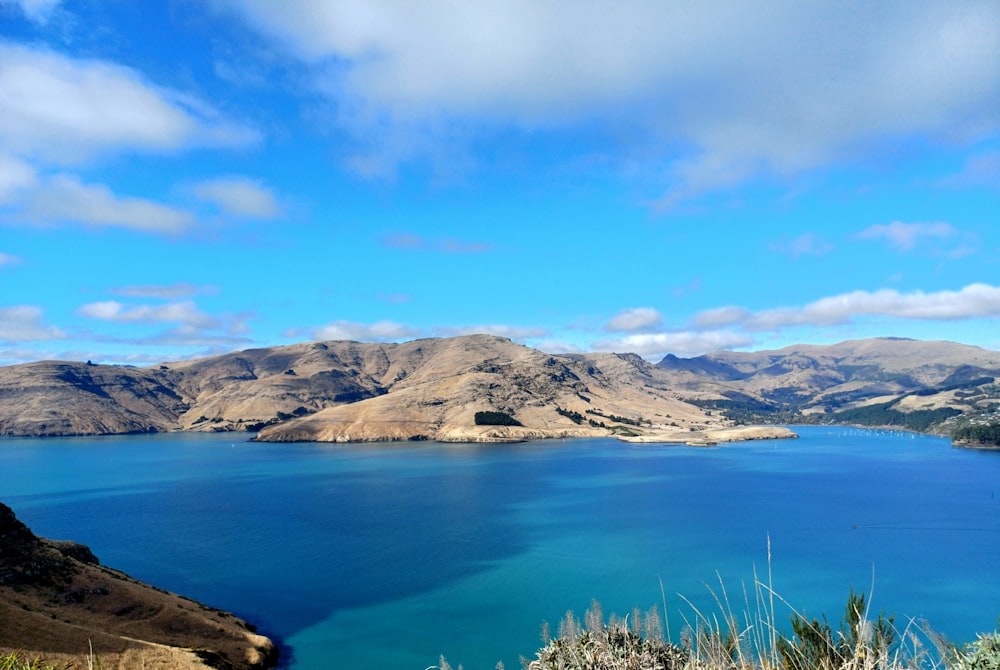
[0,504,277,670]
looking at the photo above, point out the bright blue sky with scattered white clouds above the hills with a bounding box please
[0,0,1000,365]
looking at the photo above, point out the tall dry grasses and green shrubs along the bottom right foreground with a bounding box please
[427,582,1000,670]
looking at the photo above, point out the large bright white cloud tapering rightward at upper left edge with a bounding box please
[0,41,257,164]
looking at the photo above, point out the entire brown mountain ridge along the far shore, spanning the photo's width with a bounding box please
[0,335,1000,442]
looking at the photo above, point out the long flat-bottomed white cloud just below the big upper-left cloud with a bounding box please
[20,174,194,233]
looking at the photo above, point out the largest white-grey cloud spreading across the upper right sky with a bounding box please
[219,0,1000,200]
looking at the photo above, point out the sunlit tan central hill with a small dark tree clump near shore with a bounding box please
[250,335,719,442]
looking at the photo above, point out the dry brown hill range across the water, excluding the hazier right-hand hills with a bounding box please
[0,335,721,441]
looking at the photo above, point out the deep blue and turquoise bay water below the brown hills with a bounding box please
[0,427,1000,670]
